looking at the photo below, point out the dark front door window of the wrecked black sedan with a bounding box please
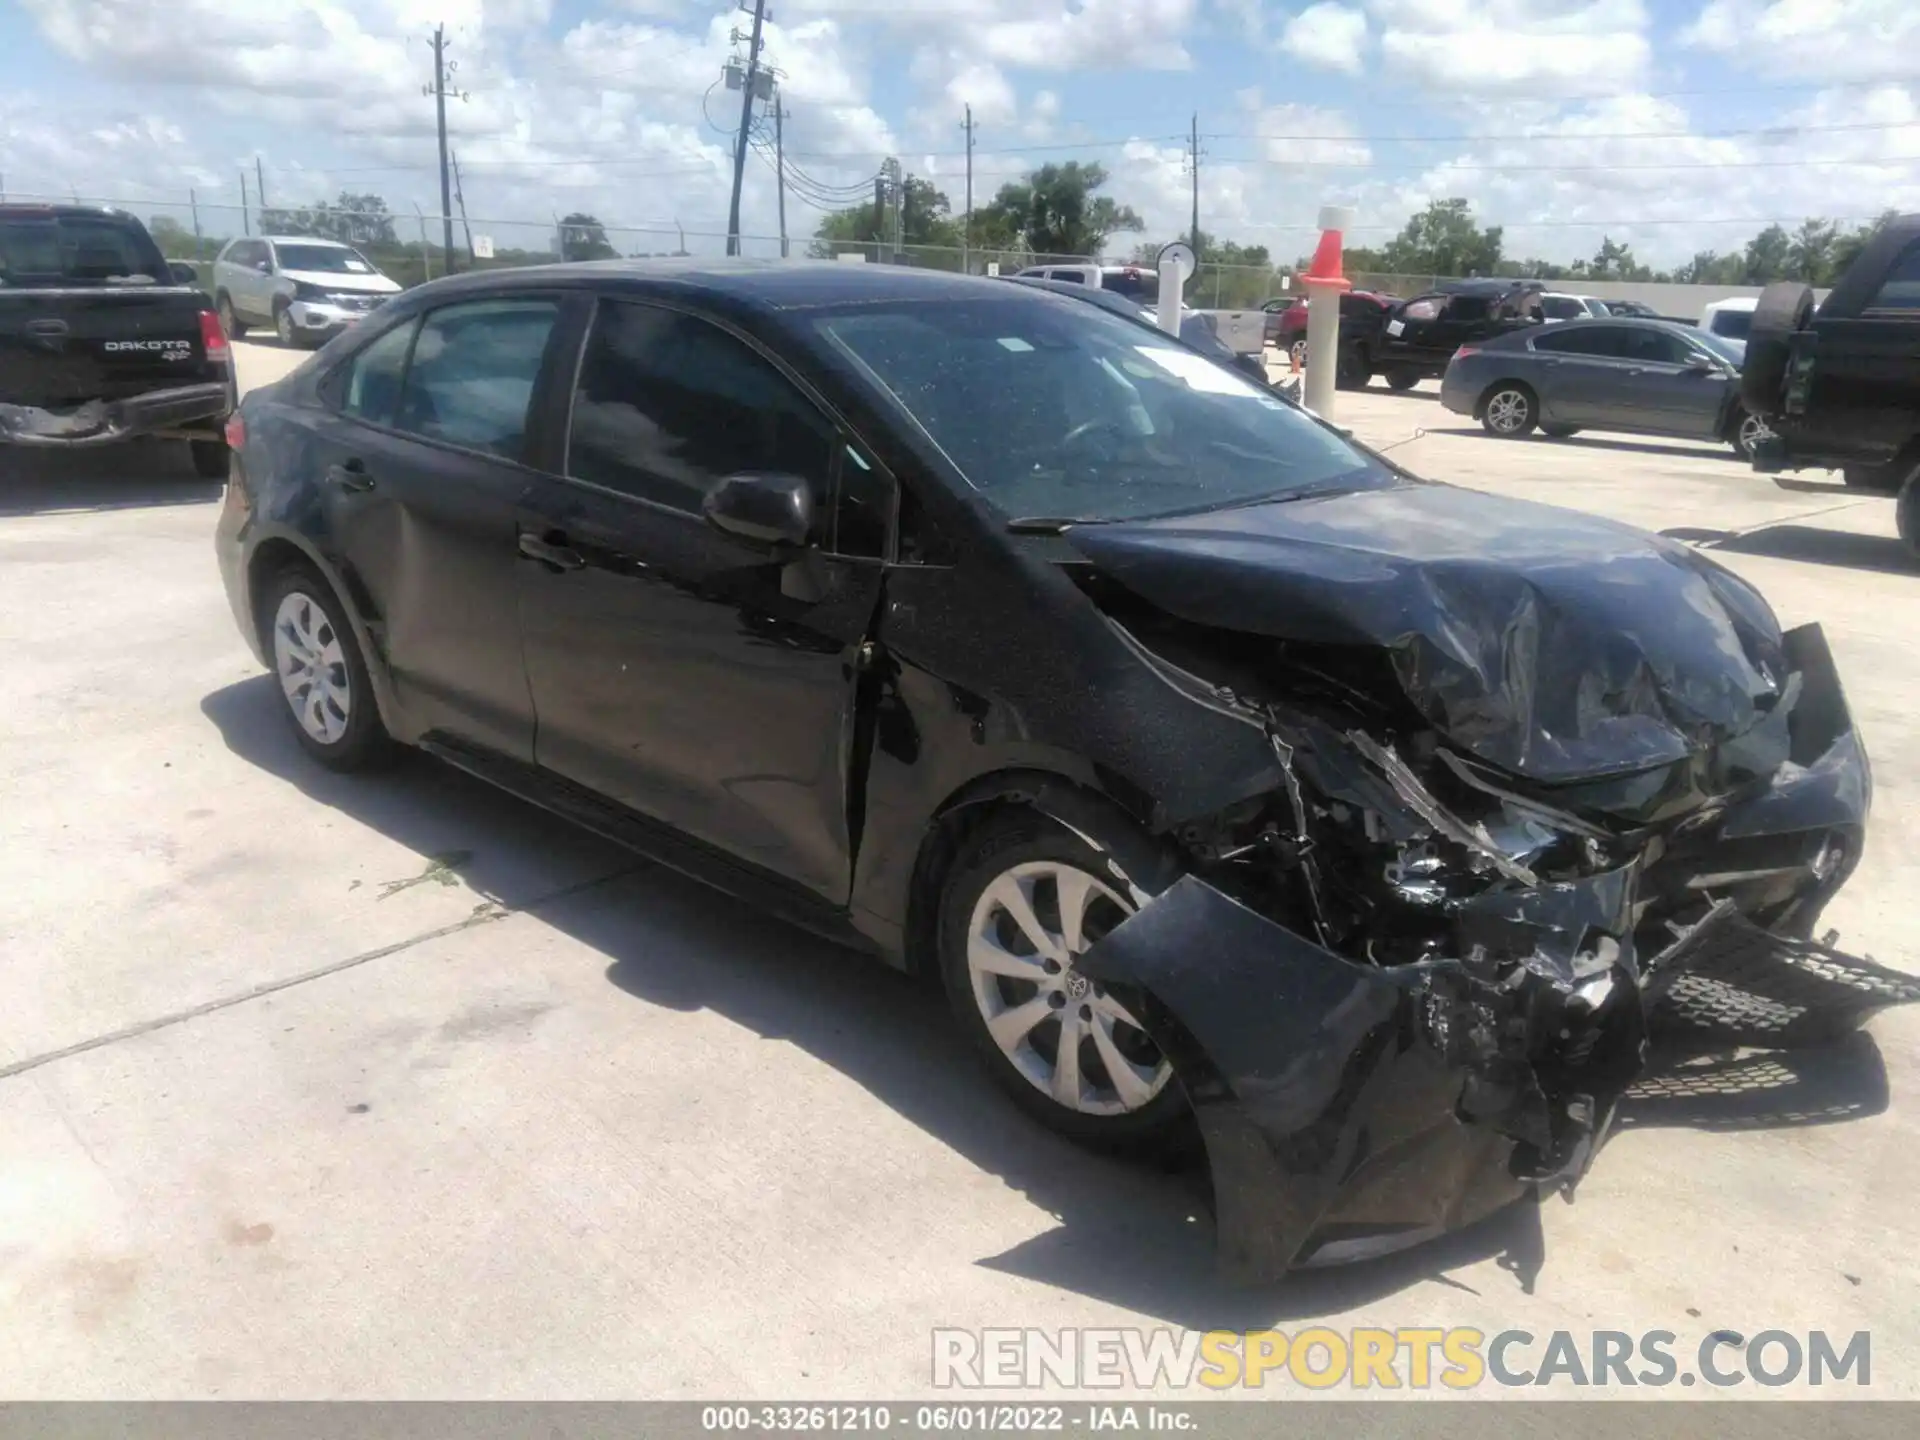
[566,301,837,515]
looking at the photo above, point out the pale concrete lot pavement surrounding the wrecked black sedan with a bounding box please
[0,344,1920,1398]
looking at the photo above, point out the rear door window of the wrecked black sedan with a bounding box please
[396,300,561,461]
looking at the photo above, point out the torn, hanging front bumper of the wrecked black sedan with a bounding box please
[1077,626,1920,1283]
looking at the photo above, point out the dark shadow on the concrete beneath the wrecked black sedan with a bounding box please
[202,676,1885,1331]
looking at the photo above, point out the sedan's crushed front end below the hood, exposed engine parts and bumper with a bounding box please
[1079,612,1920,1281]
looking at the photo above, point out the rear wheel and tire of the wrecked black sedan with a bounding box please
[259,564,397,772]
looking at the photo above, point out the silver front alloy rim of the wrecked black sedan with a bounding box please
[966,860,1173,1116]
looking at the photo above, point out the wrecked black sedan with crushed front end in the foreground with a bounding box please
[217,261,1912,1277]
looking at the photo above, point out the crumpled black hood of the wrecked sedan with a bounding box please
[1066,482,1788,781]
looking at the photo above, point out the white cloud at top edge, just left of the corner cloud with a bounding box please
[1367,0,1653,98]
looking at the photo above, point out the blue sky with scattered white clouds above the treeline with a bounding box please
[0,0,1920,263]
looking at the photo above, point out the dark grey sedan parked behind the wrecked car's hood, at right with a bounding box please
[1440,321,1768,459]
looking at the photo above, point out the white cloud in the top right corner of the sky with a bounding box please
[1680,0,1920,81]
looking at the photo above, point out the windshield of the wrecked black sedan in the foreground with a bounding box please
[814,300,1380,520]
